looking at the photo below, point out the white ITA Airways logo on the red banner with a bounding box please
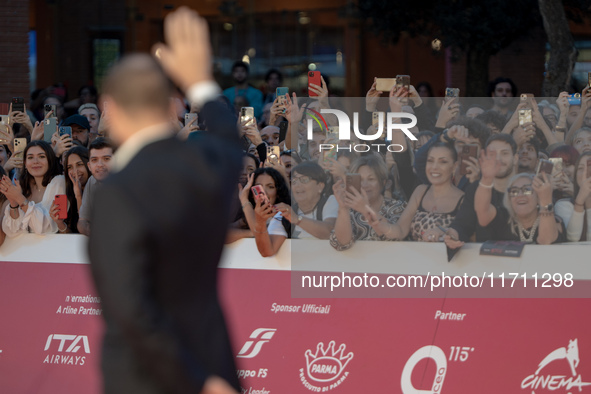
[43,334,90,366]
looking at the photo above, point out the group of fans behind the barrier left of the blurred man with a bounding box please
[0,82,114,242]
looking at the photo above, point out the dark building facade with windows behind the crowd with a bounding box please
[0,0,591,103]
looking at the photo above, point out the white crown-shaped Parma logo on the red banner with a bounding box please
[300,341,353,393]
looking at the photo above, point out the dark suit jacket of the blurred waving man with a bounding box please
[89,102,242,394]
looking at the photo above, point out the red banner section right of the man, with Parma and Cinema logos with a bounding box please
[220,269,591,394]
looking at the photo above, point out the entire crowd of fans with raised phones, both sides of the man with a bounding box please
[0,62,591,257]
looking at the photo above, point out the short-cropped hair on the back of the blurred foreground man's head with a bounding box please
[103,54,172,113]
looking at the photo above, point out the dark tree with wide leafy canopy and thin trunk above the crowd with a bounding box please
[358,0,541,96]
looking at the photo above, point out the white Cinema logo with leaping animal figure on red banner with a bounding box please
[521,338,591,394]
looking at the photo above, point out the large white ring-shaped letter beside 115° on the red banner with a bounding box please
[400,346,447,394]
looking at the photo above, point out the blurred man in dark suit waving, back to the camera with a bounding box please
[89,7,242,394]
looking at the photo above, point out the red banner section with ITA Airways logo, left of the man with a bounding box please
[0,262,103,394]
